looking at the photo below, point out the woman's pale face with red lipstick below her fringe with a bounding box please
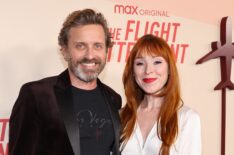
[133,55,169,94]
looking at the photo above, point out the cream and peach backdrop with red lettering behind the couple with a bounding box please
[0,0,234,155]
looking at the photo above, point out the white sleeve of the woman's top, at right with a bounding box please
[179,110,202,155]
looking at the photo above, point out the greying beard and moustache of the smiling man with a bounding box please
[67,57,106,82]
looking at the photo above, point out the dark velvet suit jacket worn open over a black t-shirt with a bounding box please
[9,70,121,155]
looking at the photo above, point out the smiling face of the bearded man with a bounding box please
[62,24,106,82]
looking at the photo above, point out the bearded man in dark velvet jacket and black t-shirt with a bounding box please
[9,9,121,155]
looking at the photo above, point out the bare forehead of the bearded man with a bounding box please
[68,24,105,43]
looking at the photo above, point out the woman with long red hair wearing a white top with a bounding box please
[121,35,201,155]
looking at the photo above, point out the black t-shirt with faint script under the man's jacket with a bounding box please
[72,87,114,155]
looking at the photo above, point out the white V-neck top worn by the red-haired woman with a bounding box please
[121,106,201,155]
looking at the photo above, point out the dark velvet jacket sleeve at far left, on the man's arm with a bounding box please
[9,85,39,155]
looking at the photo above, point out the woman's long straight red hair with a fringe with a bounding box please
[120,34,181,155]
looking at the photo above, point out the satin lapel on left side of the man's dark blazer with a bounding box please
[54,70,80,155]
